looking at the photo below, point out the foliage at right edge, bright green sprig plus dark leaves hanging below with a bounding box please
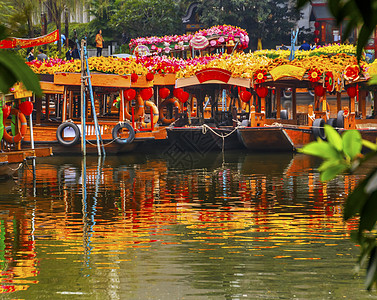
[299,125,377,290]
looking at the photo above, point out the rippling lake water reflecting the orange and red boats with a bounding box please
[0,151,377,300]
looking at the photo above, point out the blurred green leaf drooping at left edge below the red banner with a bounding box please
[0,51,42,96]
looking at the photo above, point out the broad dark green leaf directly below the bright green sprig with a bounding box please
[343,169,377,221]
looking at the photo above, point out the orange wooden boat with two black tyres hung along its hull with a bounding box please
[17,73,166,154]
